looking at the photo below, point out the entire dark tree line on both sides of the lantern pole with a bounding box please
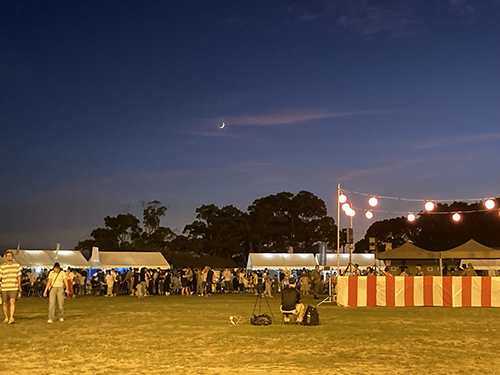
[75,195,500,257]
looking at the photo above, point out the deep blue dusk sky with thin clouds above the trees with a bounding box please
[0,0,500,249]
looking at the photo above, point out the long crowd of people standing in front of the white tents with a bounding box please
[8,266,336,298]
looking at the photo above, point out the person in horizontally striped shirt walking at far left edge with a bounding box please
[0,250,21,324]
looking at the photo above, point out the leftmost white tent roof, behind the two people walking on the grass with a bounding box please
[4,250,88,268]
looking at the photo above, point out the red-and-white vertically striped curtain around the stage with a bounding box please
[337,276,500,307]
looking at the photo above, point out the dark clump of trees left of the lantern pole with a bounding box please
[75,191,337,257]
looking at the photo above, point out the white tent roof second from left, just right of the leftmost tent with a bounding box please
[99,251,170,269]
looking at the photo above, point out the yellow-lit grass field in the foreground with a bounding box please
[0,294,500,375]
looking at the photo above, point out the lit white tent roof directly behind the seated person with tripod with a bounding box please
[247,253,317,269]
